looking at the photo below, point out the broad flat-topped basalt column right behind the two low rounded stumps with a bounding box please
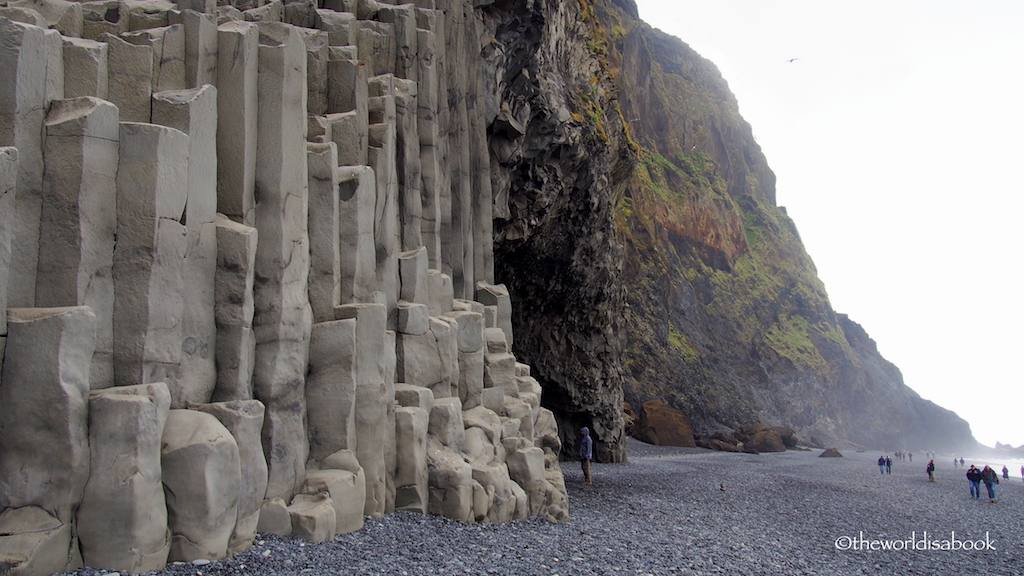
[114,122,188,389]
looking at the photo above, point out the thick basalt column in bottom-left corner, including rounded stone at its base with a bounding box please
[0,306,96,574]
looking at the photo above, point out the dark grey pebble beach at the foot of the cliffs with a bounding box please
[58,441,1024,576]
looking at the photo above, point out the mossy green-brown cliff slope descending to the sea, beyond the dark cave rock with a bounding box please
[569,0,974,449]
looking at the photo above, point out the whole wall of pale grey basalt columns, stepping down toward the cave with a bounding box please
[0,0,568,574]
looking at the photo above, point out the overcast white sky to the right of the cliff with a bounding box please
[637,0,1024,446]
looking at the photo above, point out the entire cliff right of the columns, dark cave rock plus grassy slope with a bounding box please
[485,0,974,460]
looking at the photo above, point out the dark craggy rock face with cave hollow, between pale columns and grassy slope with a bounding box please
[483,1,635,461]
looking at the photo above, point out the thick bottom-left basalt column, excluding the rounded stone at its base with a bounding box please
[0,306,96,526]
